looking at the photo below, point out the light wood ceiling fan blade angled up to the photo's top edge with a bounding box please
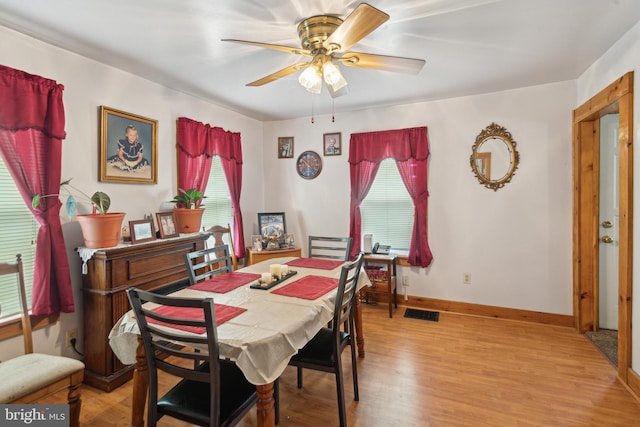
[323,3,389,53]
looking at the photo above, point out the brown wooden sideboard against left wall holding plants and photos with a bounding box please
[82,233,210,391]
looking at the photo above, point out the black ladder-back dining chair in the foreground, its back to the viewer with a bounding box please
[127,288,258,426]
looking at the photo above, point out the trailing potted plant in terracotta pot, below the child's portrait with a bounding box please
[31,179,125,249]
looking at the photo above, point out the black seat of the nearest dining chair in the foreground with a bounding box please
[158,361,256,426]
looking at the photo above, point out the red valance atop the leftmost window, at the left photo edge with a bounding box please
[0,65,65,139]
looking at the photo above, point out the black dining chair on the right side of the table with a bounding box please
[289,253,364,427]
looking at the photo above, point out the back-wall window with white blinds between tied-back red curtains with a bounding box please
[360,159,414,251]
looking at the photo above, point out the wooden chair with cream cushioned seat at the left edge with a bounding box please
[0,254,84,426]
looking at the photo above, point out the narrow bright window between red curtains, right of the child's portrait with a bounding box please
[202,156,233,236]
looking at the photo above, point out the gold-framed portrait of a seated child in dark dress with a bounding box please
[100,105,158,184]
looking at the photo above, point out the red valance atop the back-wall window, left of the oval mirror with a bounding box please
[349,127,429,164]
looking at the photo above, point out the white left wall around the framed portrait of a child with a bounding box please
[0,27,263,360]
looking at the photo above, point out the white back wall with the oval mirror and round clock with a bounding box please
[264,82,576,315]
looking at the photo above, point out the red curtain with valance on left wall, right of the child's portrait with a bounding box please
[178,117,245,258]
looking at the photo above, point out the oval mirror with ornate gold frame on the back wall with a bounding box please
[470,123,520,191]
